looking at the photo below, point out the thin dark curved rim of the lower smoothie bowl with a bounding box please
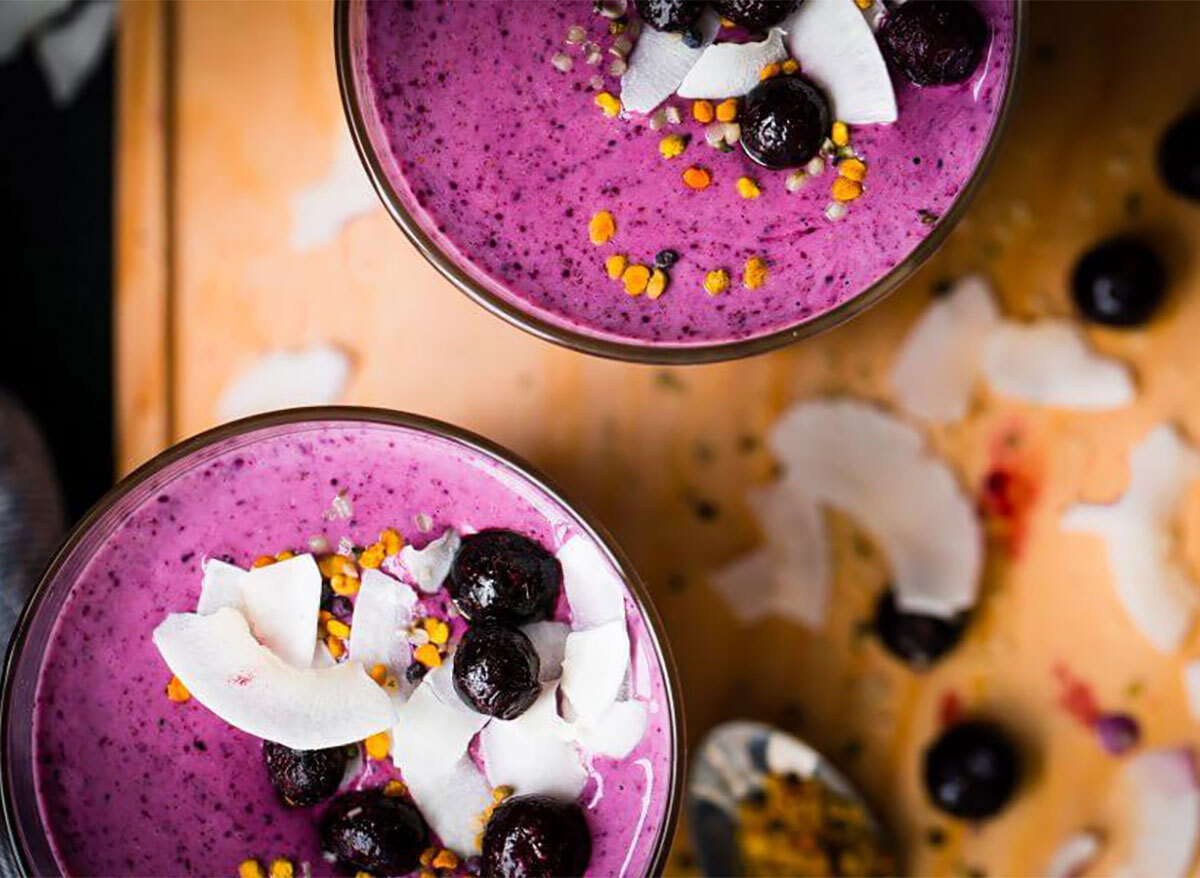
[0,405,688,874]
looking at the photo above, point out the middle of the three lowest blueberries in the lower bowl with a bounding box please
[320,789,430,874]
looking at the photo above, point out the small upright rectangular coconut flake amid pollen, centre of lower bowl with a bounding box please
[348,567,416,675]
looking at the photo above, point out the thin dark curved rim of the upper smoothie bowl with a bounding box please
[334,0,1028,366]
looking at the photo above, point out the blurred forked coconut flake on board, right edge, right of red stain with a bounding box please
[1061,425,1200,653]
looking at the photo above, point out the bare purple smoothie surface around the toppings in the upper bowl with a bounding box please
[365,0,1014,345]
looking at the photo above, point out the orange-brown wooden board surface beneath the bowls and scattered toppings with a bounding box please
[116,2,1200,874]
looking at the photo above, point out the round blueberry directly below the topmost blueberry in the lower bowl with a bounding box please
[454,625,541,720]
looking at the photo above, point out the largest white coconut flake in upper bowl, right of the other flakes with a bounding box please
[780,0,898,125]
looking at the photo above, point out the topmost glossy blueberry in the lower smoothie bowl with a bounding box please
[446,530,563,625]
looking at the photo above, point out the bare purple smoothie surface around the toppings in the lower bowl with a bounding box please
[35,423,673,876]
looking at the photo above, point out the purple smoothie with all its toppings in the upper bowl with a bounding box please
[356,0,1015,347]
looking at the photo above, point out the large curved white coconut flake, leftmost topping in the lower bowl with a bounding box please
[154,607,396,750]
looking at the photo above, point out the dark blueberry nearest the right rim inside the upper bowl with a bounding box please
[880,0,989,85]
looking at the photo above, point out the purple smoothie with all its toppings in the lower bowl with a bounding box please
[25,420,676,878]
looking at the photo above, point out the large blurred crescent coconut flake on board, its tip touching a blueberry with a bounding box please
[769,399,983,618]
